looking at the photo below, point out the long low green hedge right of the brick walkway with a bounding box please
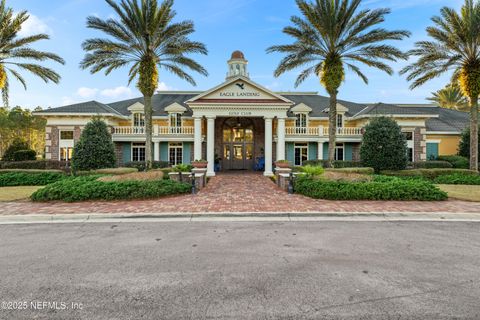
[295,177,448,201]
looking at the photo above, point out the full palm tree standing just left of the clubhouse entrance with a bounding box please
[80,0,208,168]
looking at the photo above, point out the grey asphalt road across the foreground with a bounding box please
[0,222,480,320]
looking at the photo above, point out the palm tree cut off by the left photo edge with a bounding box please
[0,0,65,107]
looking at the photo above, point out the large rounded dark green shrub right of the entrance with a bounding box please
[360,117,407,173]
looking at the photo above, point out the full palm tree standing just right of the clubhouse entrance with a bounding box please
[267,0,410,163]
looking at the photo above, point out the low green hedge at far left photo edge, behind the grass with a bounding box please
[0,171,66,187]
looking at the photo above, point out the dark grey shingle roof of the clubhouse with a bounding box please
[39,92,469,132]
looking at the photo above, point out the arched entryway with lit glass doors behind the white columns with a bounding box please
[222,118,255,170]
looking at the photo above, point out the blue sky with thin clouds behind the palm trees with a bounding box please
[7,0,463,108]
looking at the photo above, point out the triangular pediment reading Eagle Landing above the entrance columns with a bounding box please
[187,77,293,104]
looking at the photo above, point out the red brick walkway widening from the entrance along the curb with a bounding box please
[0,173,480,215]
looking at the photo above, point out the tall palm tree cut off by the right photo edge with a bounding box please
[401,0,480,171]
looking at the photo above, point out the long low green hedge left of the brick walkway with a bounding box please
[31,176,191,202]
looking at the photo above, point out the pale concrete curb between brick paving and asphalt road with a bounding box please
[0,212,480,224]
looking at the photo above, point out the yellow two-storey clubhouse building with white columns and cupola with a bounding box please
[35,51,468,176]
